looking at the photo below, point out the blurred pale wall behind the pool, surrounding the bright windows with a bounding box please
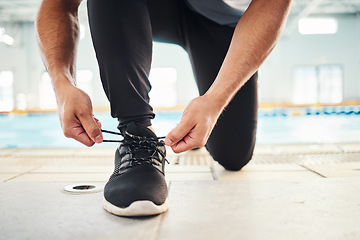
[0,11,360,109]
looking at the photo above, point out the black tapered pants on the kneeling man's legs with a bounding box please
[88,0,257,170]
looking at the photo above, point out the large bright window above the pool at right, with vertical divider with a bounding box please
[293,65,343,104]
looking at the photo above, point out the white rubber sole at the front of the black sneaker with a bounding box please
[103,198,169,217]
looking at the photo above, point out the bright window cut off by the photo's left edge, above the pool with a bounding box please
[0,71,14,112]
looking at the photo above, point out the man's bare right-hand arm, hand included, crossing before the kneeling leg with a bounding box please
[165,0,291,153]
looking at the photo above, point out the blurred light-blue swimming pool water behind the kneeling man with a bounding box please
[0,111,360,148]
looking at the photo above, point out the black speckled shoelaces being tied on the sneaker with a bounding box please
[101,129,169,172]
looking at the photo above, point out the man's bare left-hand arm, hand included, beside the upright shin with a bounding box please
[36,0,102,146]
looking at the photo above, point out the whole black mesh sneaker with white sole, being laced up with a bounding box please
[103,123,168,216]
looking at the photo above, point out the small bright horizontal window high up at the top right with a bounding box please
[298,18,338,35]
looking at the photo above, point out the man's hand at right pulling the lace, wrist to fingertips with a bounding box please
[165,95,222,153]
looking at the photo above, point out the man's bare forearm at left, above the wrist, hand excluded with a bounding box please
[36,0,81,90]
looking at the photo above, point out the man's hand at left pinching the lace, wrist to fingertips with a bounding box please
[56,84,103,147]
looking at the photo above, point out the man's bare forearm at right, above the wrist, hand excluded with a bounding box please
[205,0,291,111]
